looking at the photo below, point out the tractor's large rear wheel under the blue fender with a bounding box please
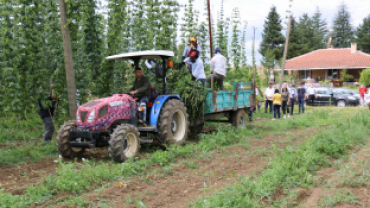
[158,100,189,145]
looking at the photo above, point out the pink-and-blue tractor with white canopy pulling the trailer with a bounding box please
[57,51,189,162]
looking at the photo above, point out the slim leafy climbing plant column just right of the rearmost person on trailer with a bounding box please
[230,7,241,70]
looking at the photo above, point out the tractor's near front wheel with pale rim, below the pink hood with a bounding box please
[108,124,140,162]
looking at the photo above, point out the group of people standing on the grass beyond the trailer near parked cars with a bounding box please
[264,82,316,120]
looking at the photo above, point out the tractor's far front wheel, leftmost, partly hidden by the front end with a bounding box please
[57,121,85,158]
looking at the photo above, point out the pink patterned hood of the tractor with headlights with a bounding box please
[76,94,137,130]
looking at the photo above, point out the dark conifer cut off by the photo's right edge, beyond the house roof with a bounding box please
[356,15,370,53]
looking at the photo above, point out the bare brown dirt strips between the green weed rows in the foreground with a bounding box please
[0,108,370,207]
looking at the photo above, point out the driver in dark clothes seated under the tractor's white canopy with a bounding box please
[130,68,151,126]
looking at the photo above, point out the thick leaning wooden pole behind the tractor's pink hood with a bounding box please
[58,0,77,120]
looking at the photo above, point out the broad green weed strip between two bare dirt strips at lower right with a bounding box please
[194,112,370,208]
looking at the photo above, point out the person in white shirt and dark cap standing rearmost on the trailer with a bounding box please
[206,47,227,90]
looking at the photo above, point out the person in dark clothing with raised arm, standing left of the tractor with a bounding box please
[38,84,56,144]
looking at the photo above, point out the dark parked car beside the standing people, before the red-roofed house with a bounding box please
[306,87,359,107]
